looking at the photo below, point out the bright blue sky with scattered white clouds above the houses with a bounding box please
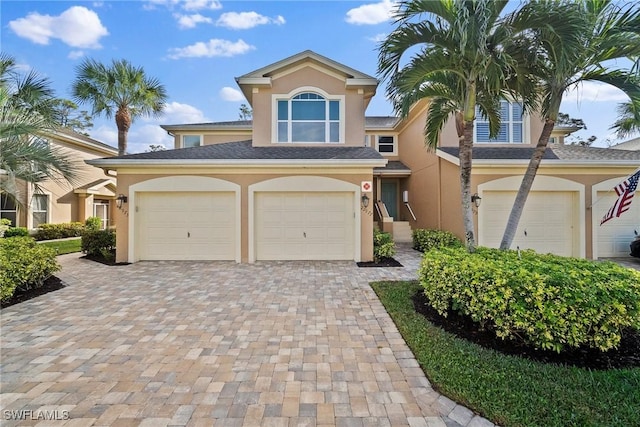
[0,0,626,152]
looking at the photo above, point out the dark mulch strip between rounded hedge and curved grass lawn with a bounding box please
[413,292,640,370]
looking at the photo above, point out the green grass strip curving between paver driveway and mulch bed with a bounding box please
[371,282,640,427]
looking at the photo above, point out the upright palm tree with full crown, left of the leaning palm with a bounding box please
[378,0,552,251]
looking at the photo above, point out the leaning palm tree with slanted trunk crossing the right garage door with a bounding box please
[500,0,640,249]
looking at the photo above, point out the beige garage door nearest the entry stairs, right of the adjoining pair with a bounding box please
[255,192,356,260]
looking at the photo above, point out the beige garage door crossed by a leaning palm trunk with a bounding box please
[479,191,579,256]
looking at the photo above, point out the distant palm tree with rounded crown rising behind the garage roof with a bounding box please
[72,59,167,156]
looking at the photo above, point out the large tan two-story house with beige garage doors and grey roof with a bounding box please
[88,51,640,262]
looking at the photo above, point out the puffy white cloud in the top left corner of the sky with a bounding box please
[9,6,109,49]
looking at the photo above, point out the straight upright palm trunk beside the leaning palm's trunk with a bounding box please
[459,120,476,252]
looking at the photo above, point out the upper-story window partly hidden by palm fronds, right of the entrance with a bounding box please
[474,100,525,144]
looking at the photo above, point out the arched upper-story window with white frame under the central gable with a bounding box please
[276,92,341,143]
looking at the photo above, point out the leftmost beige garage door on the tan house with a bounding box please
[136,192,236,260]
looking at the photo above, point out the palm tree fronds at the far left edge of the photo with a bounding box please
[0,54,75,211]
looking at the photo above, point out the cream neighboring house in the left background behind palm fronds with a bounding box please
[0,129,118,229]
